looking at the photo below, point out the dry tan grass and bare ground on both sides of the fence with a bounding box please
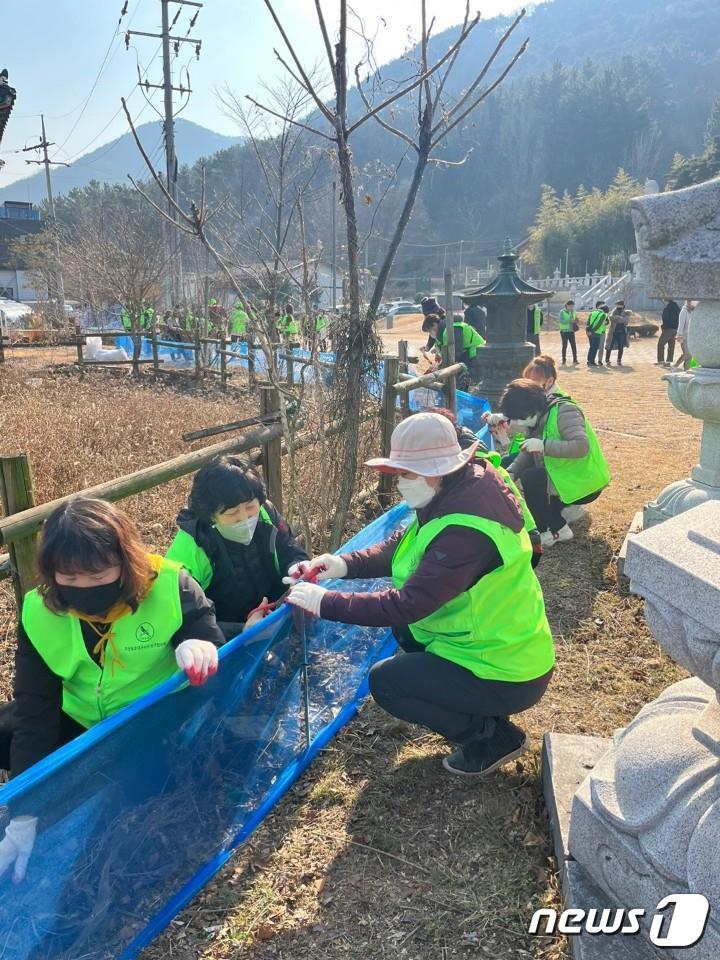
[0,331,699,960]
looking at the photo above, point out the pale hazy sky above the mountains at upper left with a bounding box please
[0,0,520,186]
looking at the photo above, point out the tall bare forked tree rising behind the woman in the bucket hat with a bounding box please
[256,0,525,545]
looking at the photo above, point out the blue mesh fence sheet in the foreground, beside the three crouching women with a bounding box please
[0,504,410,960]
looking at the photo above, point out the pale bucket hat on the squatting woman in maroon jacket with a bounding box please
[365,413,480,477]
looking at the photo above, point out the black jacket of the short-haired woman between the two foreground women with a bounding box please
[177,500,308,636]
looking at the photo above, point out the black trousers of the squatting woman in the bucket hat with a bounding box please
[370,631,551,744]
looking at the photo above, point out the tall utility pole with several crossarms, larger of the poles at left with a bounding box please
[125,0,203,307]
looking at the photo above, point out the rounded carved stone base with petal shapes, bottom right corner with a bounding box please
[569,678,720,960]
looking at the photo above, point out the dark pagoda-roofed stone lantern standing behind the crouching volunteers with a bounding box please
[460,240,552,404]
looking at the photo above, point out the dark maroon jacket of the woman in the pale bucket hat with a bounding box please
[320,463,523,627]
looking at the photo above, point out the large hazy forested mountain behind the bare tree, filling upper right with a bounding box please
[47,0,720,277]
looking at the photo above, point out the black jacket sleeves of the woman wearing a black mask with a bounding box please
[10,570,225,777]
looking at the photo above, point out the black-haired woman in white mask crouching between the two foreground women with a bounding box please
[167,456,307,638]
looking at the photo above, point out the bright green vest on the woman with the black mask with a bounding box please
[22,560,183,728]
